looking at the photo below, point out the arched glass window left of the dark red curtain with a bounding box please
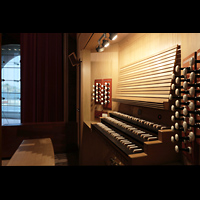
[1,44,21,125]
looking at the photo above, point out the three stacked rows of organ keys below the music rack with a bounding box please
[92,112,167,155]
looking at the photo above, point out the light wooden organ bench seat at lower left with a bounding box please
[7,138,55,166]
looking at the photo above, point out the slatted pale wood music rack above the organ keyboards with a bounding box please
[117,45,180,107]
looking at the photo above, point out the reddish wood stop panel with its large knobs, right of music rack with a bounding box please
[169,49,200,164]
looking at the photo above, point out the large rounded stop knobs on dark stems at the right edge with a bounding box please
[169,57,200,154]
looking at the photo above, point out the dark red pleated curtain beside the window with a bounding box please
[20,33,63,123]
